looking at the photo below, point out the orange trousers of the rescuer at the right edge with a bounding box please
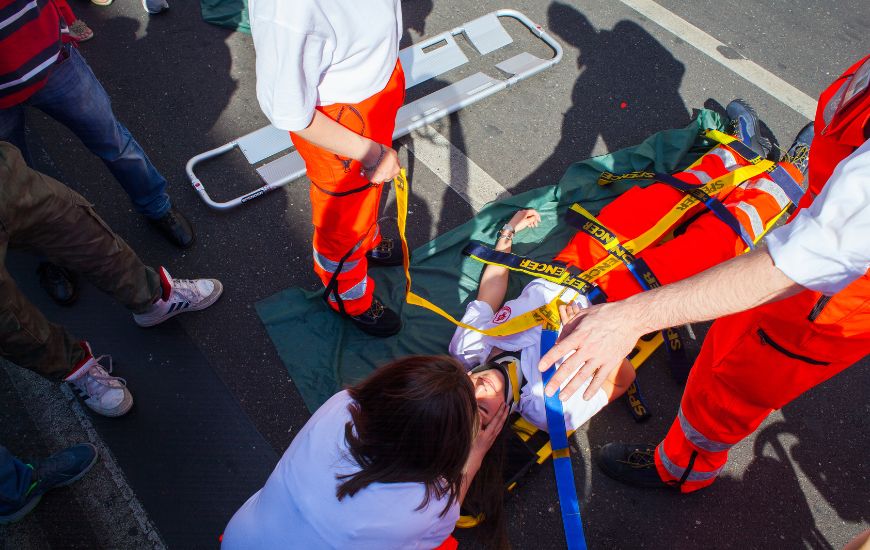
[655,294,870,493]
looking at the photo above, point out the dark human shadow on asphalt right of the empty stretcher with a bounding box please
[520,2,690,189]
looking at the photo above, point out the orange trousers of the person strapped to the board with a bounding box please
[555,145,801,301]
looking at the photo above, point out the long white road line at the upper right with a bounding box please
[621,0,816,120]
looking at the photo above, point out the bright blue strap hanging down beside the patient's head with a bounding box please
[541,329,586,550]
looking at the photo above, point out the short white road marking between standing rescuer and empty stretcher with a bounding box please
[408,126,511,212]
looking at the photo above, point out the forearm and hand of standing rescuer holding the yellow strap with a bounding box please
[294,110,402,183]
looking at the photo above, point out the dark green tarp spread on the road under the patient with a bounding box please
[256,110,724,412]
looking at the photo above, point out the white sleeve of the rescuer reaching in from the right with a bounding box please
[766,140,870,296]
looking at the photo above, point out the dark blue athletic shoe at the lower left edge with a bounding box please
[0,443,99,525]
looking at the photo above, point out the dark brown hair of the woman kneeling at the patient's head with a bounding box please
[336,355,478,516]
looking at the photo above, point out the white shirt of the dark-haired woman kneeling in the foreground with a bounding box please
[221,391,459,550]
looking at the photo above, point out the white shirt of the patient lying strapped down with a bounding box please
[450,279,607,431]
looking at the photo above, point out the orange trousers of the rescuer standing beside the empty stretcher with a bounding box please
[290,62,405,315]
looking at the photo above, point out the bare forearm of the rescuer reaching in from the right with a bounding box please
[612,250,803,334]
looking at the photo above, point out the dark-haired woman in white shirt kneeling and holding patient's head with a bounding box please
[222,356,507,550]
